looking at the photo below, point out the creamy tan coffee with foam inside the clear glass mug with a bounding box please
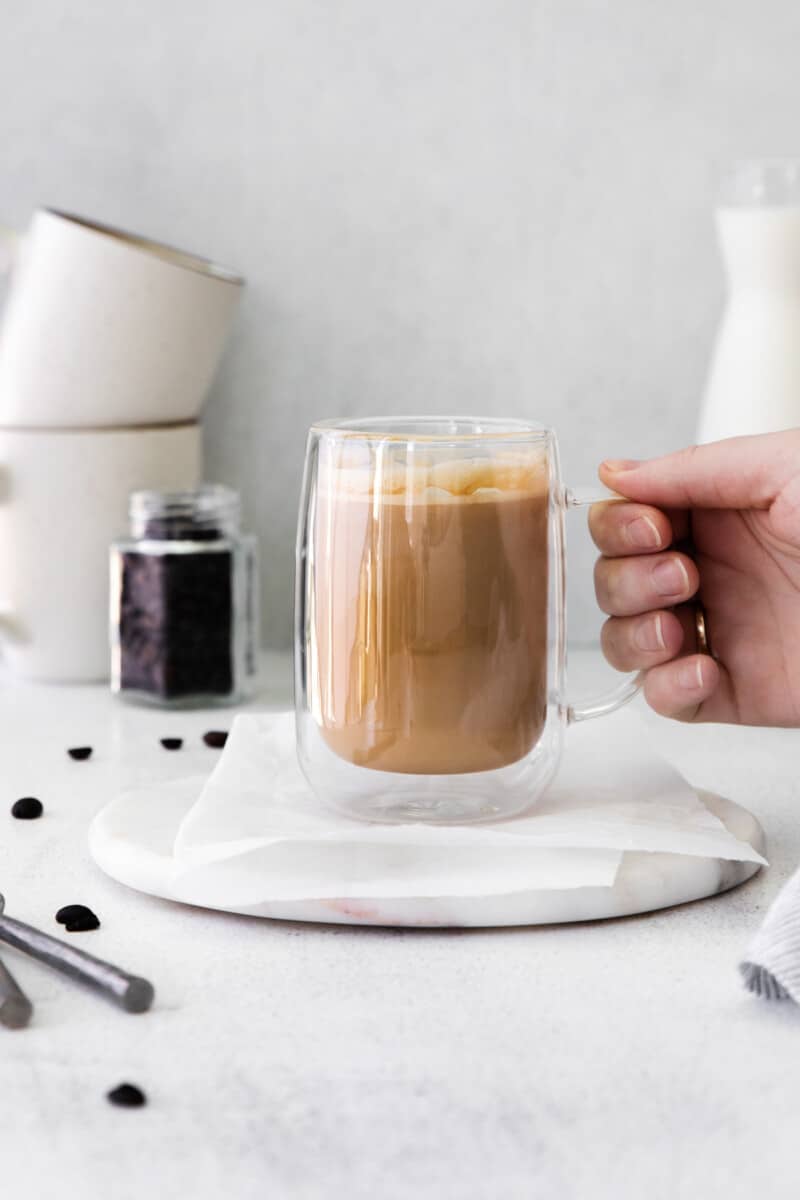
[307,446,549,775]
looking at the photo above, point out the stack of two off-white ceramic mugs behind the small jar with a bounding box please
[0,209,243,682]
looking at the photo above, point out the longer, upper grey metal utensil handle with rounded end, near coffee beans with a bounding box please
[0,893,155,1013]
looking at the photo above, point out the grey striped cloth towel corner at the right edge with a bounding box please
[739,870,800,1004]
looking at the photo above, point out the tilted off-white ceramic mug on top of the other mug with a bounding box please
[0,209,243,428]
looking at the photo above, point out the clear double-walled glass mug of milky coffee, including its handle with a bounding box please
[295,416,639,822]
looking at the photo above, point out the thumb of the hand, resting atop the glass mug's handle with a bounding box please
[600,430,800,509]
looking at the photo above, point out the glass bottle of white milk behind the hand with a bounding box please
[697,158,800,442]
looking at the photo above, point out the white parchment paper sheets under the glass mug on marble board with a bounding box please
[159,713,764,905]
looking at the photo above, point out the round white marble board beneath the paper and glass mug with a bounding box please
[89,791,764,928]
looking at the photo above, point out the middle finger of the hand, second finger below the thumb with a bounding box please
[595,552,699,617]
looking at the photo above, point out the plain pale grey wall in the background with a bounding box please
[0,0,800,644]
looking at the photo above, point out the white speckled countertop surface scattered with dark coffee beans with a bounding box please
[0,655,800,1200]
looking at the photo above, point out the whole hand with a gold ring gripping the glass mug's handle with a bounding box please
[589,430,800,726]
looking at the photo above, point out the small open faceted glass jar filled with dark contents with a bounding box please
[110,485,258,708]
